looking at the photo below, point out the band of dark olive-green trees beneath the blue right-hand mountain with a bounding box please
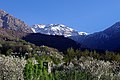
[64,48,120,62]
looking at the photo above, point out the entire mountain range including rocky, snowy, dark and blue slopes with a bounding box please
[0,10,120,52]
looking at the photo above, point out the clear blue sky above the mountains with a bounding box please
[0,0,120,33]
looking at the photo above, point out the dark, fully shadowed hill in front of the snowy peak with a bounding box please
[22,33,80,51]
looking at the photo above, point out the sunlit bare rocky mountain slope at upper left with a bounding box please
[0,10,33,33]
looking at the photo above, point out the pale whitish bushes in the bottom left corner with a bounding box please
[0,54,26,80]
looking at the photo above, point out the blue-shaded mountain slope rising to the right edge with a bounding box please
[70,22,120,51]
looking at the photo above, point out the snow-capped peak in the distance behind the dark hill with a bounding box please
[31,24,87,37]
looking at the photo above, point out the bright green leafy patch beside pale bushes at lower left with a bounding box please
[24,60,52,80]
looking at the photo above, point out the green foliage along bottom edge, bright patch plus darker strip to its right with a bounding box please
[24,59,95,80]
